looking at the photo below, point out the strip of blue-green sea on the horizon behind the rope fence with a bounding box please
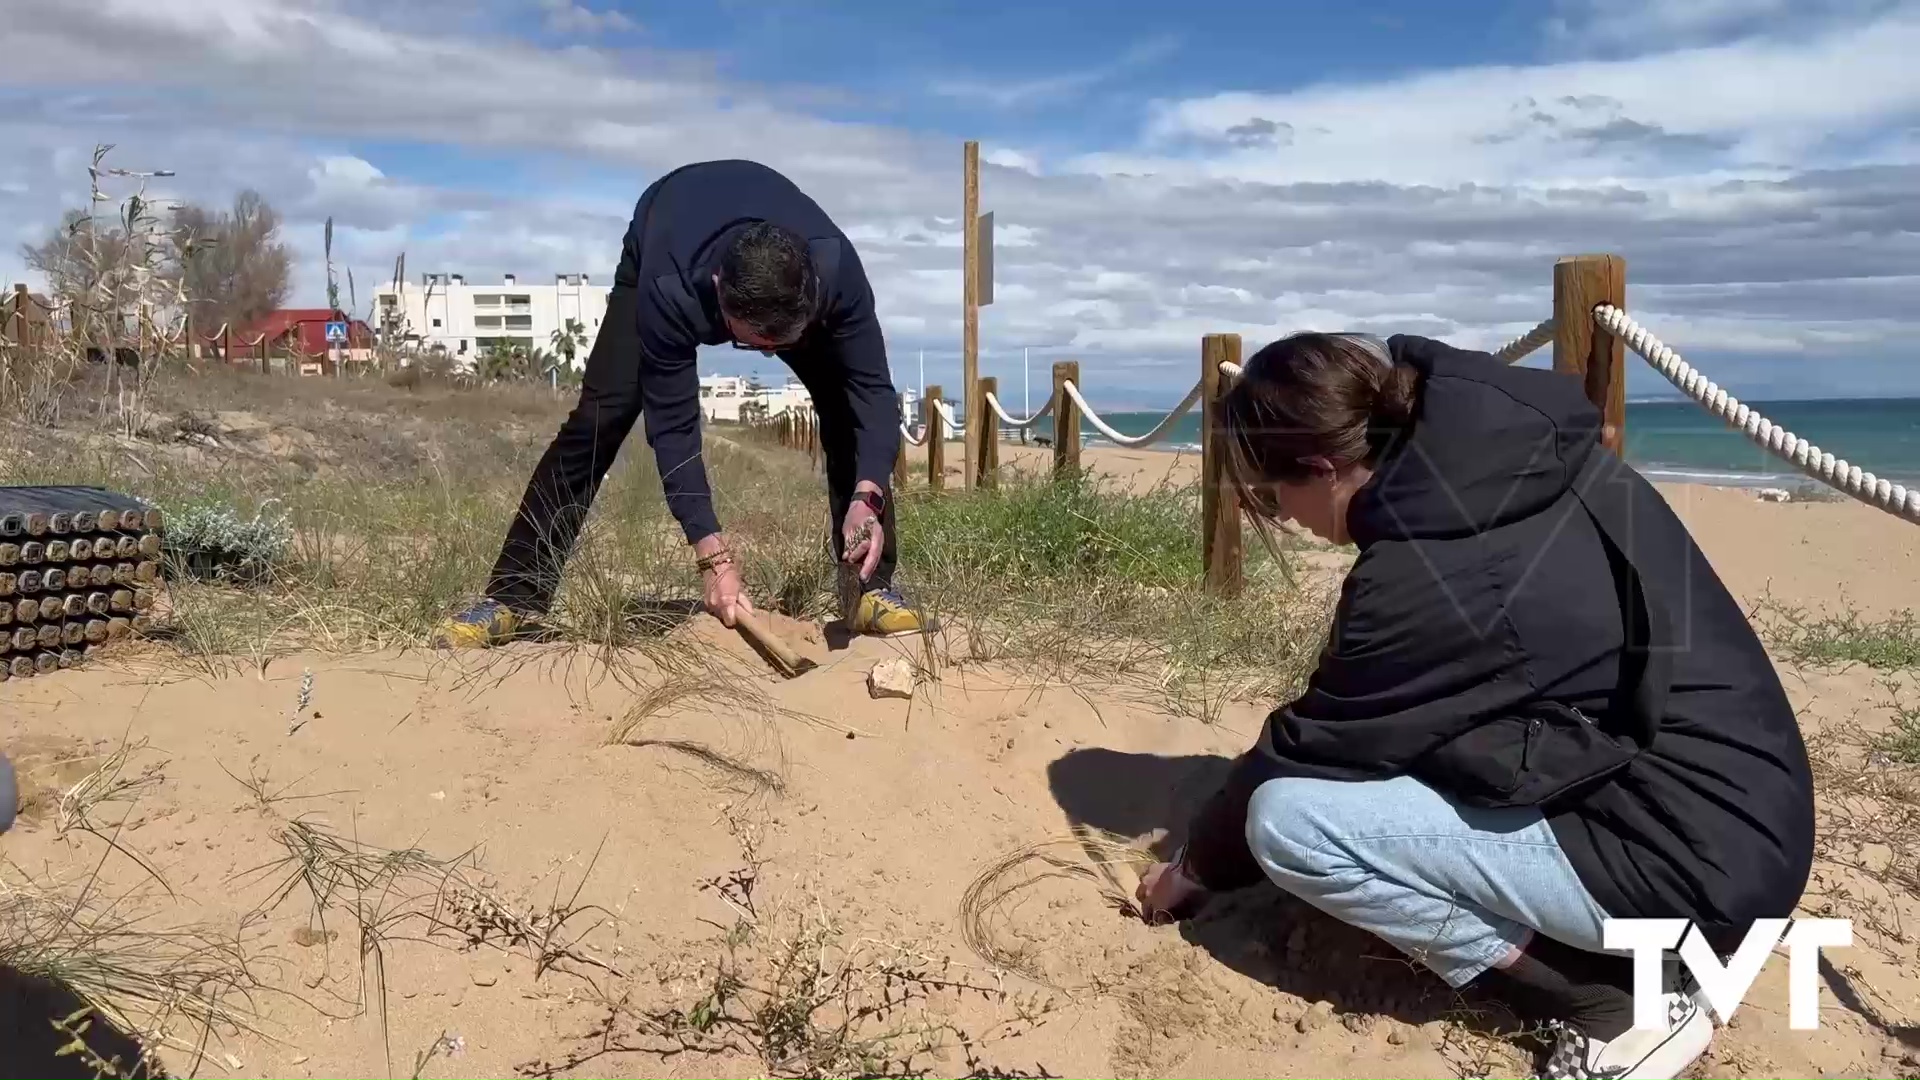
[1008,398,1920,488]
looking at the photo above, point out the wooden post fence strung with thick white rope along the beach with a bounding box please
[756,256,1920,594]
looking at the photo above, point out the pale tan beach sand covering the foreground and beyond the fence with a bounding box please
[11,446,1920,1080]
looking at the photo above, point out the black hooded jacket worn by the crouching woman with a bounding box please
[1187,336,1812,947]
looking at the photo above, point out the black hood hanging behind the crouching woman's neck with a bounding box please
[1346,334,1601,550]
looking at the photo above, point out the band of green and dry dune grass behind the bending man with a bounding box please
[0,343,1329,715]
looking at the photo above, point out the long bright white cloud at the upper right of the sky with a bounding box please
[1098,10,1920,186]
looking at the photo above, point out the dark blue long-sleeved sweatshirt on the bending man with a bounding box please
[614,161,900,542]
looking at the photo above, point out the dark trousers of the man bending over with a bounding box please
[486,282,897,615]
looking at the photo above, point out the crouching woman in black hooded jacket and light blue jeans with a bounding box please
[1140,334,1812,1080]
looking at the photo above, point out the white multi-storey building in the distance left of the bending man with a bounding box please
[372,273,607,365]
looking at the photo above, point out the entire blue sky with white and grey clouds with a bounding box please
[0,0,1920,407]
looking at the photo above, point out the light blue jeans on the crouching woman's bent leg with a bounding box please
[1246,776,1607,986]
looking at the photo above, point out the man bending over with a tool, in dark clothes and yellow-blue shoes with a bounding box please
[436,161,924,648]
